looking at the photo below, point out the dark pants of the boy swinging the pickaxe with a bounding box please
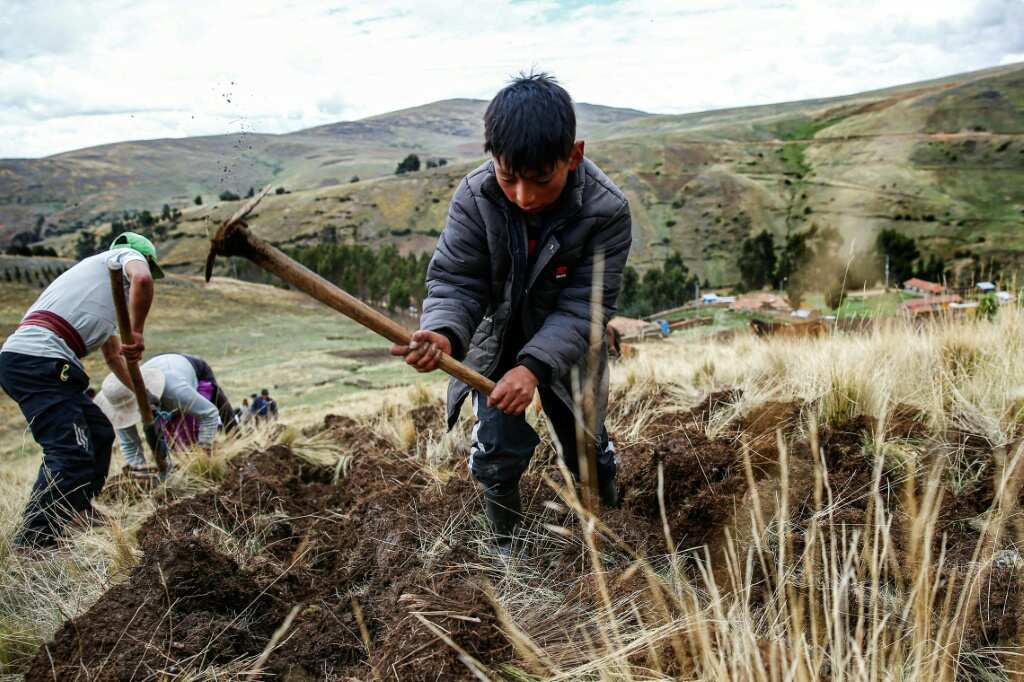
[469,388,615,496]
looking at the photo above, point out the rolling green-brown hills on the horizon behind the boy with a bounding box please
[0,59,1024,284]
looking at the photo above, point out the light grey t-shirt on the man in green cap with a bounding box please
[0,249,145,367]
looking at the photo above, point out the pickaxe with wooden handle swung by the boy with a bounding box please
[206,187,495,395]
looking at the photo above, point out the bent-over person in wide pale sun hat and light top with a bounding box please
[96,353,238,469]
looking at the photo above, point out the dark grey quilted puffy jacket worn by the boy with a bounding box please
[420,159,632,428]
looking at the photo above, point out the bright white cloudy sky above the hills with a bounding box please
[0,0,1024,157]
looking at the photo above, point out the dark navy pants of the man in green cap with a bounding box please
[0,352,114,546]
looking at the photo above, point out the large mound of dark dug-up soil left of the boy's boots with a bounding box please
[26,419,512,680]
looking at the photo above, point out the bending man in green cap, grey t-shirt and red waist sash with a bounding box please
[0,232,164,549]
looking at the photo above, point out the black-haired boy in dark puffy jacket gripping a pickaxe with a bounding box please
[391,74,631,554]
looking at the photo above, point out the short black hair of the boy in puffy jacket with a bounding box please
[483,73,575,175]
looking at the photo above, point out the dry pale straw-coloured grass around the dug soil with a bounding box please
[0,307,1024,681]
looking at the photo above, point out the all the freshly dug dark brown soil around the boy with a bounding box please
[26,392,1022,681]
